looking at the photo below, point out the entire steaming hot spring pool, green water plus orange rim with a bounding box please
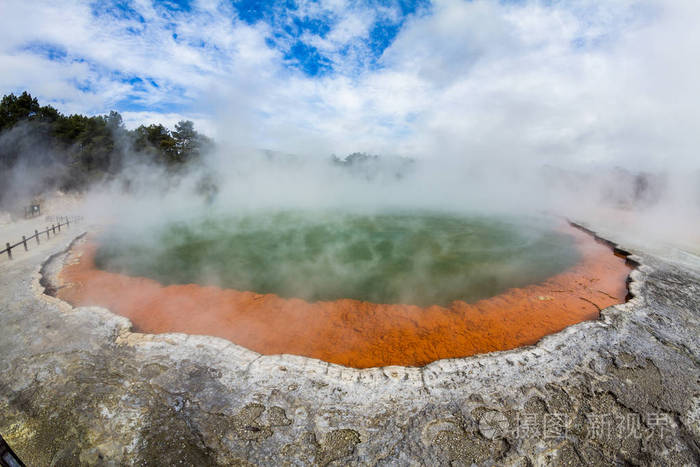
[57,212,629,368]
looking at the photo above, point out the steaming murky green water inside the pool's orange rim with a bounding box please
[96,212,579,306]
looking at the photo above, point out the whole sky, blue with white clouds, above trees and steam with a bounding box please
[0,0,700,168]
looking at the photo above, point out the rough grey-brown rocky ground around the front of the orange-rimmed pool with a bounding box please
[0,218,700,466]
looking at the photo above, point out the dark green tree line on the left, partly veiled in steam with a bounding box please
[0,91,213,207]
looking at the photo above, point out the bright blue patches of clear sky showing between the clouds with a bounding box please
[6,0,430,124]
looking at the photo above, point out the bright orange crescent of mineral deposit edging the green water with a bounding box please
[58,228,630,368]
